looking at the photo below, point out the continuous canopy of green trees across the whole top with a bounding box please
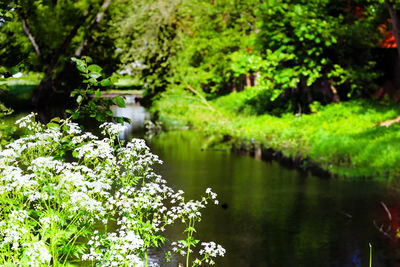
[0,0,399,114]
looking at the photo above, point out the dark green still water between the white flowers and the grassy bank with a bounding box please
[148,131,400,267]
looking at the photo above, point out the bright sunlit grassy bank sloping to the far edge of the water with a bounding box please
[153,88,400,179]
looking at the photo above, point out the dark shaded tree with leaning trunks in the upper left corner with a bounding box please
[0,0,119,108]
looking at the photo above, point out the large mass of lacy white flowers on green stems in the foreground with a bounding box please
[0,115,223,266]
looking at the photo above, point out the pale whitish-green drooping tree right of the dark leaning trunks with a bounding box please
[113,0,184,103]
